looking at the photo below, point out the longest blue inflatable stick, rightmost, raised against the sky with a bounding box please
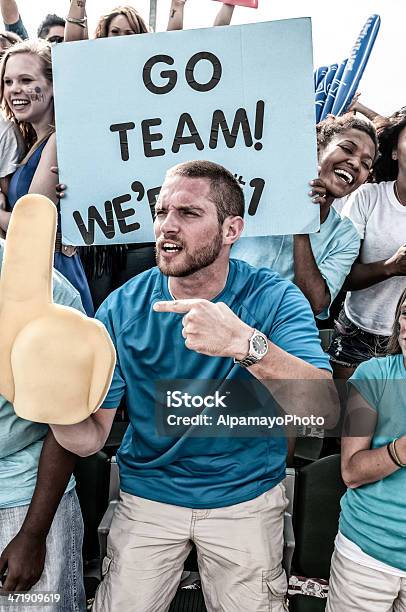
[329,15,381,116]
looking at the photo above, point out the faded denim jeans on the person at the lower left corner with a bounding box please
[0,489,86,612]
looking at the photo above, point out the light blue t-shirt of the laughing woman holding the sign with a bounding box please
[231,208,361,319]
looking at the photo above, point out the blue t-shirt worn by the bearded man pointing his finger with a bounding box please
[96,259,330,508]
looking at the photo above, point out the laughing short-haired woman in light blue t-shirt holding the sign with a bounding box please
[232,115,378,319]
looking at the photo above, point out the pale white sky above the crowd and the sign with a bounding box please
[7,0,406,114]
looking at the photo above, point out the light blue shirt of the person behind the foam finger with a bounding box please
[0,240,84,508]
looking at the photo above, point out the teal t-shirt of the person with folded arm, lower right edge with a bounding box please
[340,355,406,571]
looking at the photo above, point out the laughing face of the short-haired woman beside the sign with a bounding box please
[319,128,376,198]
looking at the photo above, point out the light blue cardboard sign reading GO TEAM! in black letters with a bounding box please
[53,18,319,245]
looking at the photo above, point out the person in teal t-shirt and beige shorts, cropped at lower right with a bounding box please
[326,288,406,612]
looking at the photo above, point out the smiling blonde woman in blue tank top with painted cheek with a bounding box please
[0,40,94,316]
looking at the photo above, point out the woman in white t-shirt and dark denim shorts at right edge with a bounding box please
[328,113,406,379]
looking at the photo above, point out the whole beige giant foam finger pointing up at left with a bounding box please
[0,195,115,425]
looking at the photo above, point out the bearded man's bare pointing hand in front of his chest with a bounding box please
[154,299,253,359]
